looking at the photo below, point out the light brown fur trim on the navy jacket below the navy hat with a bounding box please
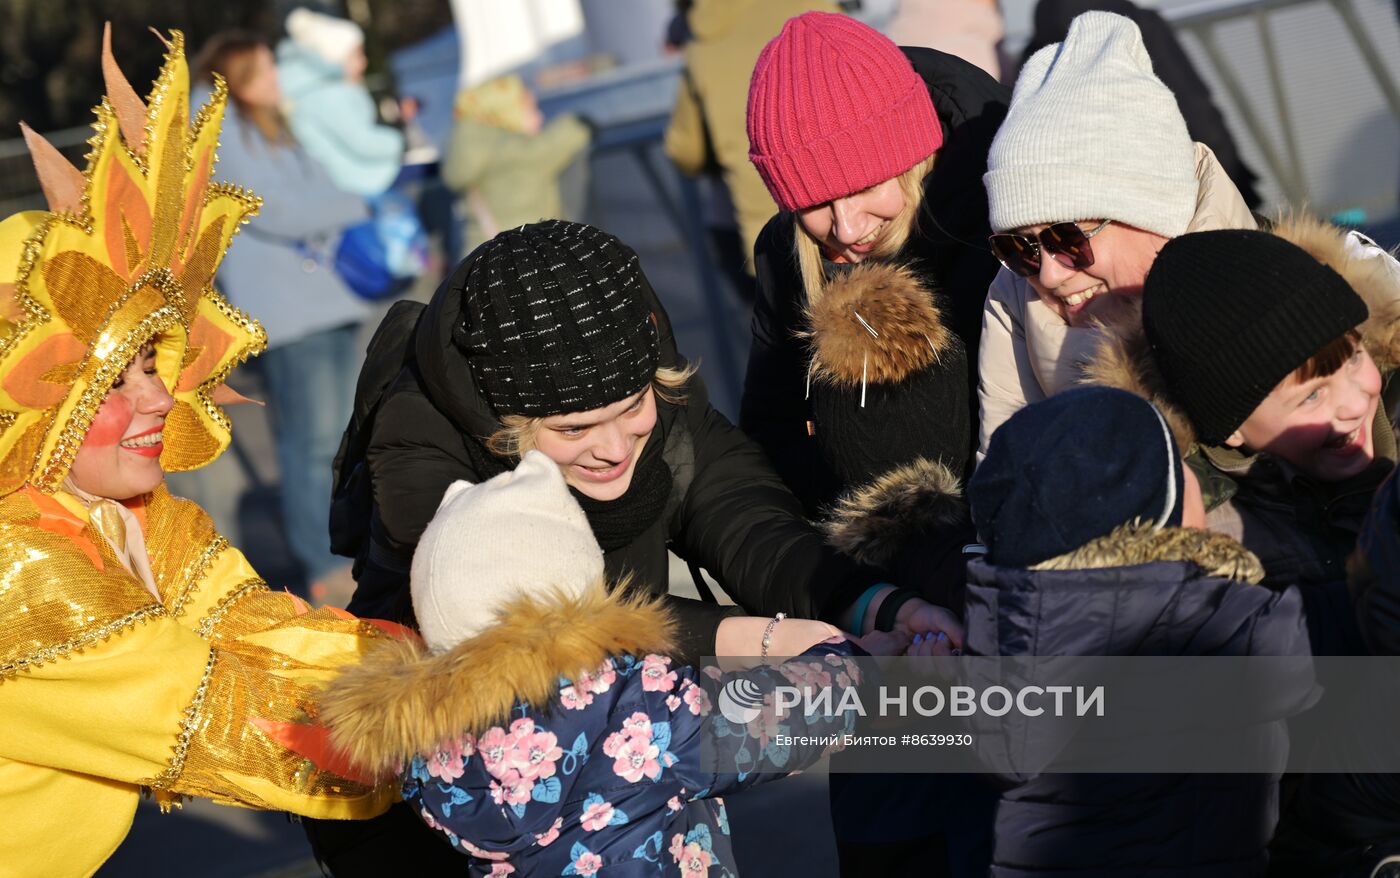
[1032,521,1264,584]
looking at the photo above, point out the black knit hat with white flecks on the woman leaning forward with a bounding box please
[454,220,661,417]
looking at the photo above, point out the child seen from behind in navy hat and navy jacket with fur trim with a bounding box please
[957,388,1316,878]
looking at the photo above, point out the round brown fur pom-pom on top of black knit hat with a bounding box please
[802,262,956,386]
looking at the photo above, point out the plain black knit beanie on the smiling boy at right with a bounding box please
[1142,230,1366,444]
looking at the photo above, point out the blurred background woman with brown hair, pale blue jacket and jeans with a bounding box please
[195,31,370,605]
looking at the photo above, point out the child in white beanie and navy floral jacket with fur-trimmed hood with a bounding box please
[322,451,860,877]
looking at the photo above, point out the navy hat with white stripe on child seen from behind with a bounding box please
[967,386,1183,567]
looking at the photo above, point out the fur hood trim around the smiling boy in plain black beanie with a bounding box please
[1082,214,1400,454]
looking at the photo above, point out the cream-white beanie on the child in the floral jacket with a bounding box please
[409,451,603,653]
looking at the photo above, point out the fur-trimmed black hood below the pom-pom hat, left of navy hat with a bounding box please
[822,458,967,567]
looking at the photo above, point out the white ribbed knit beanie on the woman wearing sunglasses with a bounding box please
[983,13,1197,238]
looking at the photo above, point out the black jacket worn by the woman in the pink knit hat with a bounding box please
[739,48,1011,517]
